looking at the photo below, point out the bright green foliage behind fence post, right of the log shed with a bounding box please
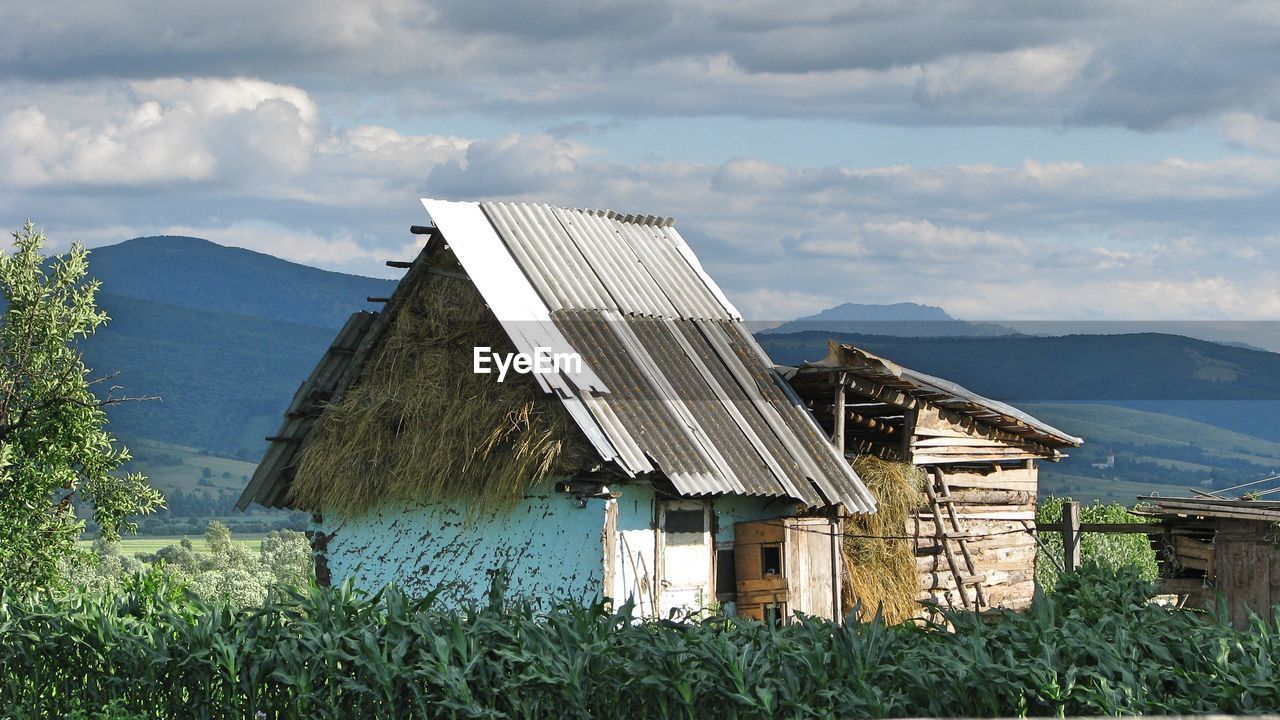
[1036,495,1158,592]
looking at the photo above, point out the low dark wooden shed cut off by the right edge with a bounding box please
[1135,497,1280,626]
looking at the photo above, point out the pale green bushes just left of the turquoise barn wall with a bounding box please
[64,520,311,607]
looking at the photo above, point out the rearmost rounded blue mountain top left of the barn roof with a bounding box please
[90,236,396,328]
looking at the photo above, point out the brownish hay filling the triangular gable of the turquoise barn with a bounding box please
[291,254,589,515]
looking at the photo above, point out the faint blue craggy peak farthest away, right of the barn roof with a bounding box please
[762,302,1014,337]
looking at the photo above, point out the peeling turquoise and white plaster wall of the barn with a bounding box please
[314,483,792,618]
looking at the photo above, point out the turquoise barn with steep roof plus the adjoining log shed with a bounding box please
[238,200,1079,621]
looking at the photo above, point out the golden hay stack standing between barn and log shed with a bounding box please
[842,455,925,623]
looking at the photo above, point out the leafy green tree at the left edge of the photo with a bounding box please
[0,223,164,592]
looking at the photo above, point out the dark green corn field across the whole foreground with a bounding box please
[0,566,1280,719]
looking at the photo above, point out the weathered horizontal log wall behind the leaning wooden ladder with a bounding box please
[906,468,1038,609]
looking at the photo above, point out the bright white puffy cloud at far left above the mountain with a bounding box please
[0,78,317,187]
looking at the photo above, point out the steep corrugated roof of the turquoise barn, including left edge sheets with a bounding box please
[239,200,876,512]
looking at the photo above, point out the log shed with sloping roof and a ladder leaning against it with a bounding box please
[785,342,1082,610]
